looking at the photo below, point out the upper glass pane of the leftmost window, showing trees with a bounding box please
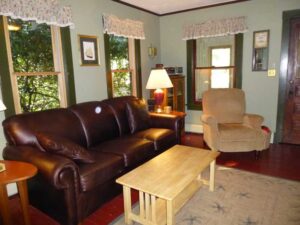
[8,18,54,72]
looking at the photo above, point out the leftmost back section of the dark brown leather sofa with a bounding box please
[2,108,86,146]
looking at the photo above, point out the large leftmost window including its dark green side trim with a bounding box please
[0,16,76,116]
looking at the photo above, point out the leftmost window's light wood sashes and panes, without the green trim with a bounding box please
[4,18,66,113]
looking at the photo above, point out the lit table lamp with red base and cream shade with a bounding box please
[146,68,173,112]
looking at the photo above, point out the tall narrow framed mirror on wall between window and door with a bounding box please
[252,30,269,71]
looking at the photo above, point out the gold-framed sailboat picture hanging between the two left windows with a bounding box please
[78,35,100,66]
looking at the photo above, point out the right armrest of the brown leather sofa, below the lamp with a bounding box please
[149,113,185,143]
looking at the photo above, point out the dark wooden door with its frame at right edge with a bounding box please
[276,10,300,144]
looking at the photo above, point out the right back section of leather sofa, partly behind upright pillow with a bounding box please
[102,96,137,136]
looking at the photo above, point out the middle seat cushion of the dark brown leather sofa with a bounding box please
[91,136,154,167]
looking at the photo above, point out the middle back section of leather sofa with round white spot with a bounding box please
[69,101,120,147]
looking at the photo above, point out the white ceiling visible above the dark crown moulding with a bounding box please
[118,0,242,15]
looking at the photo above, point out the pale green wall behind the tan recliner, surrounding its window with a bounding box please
[160,0,300,132]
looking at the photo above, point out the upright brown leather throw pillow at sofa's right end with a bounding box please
[127,99,150,134]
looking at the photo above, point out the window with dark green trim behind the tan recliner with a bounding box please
[187,34,243,110]
